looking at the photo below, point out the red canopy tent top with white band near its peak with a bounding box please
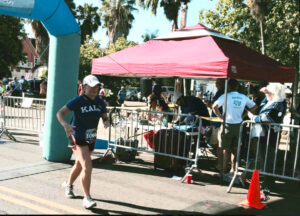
[92,24,295,82]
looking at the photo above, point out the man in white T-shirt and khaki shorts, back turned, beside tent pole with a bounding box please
[213,79,257,172]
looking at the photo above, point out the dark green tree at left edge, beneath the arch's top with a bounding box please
[0,15,25,78]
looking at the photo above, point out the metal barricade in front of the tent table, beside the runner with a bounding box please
[104,108,203,181]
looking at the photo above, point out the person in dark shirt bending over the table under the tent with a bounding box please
[174,93,210,127]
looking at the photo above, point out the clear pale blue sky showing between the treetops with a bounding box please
[25,0,217,47]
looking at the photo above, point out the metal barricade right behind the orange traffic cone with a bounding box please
[227,121,300,192]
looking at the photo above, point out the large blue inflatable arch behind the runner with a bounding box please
[0,0,80,162]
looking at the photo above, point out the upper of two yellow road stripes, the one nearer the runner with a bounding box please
[0,186,87,214]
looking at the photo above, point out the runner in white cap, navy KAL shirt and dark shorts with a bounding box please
[57,75,109,208]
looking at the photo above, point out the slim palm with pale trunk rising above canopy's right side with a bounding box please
[247,0,267,54]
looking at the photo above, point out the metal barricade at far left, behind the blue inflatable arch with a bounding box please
[1,96,46,132]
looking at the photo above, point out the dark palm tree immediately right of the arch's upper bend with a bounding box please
[76,3,101,43]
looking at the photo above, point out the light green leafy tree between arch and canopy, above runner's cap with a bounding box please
[78,35,105,80]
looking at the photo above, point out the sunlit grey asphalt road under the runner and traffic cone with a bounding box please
[0,128,300,215]
